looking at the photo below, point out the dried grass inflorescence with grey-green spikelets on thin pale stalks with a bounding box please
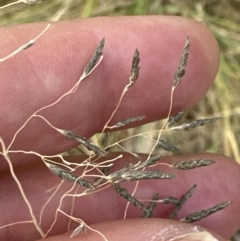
[0,0,231,240]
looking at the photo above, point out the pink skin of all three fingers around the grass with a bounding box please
[0,17,240,241]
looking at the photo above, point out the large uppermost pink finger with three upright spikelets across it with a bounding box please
[0,16,219,163]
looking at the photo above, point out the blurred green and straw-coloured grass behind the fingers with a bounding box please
[0,0,240,240]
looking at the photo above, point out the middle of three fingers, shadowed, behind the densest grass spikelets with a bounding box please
[0,154,240,241]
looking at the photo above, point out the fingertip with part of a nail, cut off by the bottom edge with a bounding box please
[39,219,225,241]
